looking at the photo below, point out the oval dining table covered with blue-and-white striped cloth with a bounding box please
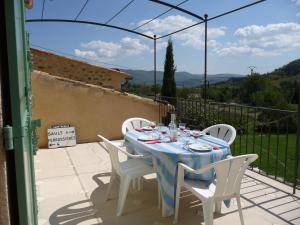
[124,129,231,217]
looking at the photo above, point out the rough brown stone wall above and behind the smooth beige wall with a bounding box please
[31,48,129,90]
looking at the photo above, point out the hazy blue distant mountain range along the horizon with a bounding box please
[122,70,245,87]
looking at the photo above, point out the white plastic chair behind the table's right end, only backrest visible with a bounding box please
[202,124,236,145]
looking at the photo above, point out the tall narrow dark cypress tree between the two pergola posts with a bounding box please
[161,39,176,105]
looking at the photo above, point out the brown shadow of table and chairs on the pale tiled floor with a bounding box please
[49,173,221,225]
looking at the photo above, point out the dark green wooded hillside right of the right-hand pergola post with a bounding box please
[208,59,300,109]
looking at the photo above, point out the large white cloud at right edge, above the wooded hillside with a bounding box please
[216,23,300,56]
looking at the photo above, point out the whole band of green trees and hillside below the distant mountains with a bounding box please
[128,59,300,110]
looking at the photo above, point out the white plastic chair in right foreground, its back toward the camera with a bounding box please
[174,154,258,225]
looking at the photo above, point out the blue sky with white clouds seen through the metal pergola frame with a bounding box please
[26,0,300,74]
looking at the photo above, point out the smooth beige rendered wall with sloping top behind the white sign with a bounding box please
[32,71,159,147]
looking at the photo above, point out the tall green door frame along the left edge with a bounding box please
[2,0,37,225]
